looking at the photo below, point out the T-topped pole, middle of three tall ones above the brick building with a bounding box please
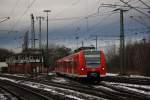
[36,16,44,49]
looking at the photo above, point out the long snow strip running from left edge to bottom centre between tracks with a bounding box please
[0,77,107,100]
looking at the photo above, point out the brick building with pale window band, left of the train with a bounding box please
[6,49,47,74]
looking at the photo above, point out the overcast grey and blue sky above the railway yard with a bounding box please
[0,0,150,50]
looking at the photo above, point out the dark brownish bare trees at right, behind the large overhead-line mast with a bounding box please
[108,42,150,76]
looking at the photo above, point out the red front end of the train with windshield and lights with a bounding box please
[80,51,106,80]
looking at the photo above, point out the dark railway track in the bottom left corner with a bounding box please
[0,80,52,100]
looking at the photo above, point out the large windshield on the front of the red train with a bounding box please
[84,51,100,68]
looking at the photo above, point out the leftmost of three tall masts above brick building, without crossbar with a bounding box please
[31,14,35,48]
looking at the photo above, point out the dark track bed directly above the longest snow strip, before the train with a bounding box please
[0,74,127,100]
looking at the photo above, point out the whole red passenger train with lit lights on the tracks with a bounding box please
[55,47,107,81]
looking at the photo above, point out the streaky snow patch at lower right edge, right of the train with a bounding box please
[105,82,150,95]
